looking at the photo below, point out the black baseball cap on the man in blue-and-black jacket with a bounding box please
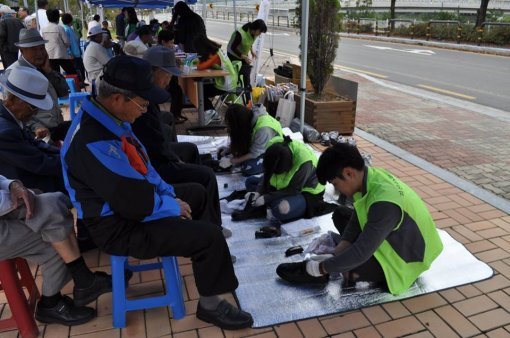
[101,55,170,104]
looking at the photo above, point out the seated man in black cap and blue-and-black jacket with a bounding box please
[62,56,253,329]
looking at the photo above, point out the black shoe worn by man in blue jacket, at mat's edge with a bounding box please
[197,300,253,330]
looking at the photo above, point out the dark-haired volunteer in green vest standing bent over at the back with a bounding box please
[227,19,267,88]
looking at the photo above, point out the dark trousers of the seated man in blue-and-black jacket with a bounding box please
[85,216,238,296]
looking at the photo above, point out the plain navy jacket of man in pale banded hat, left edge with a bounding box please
[0,104,65,192]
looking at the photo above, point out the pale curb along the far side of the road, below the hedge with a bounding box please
[340,33,510,56]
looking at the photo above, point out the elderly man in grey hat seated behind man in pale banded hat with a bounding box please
[6,29,70,141]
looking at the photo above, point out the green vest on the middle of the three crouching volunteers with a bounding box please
[268,136,325,195]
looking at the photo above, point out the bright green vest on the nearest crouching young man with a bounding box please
[353,167,443,295]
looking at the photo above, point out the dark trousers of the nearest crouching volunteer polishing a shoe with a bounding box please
[333,206,388,288]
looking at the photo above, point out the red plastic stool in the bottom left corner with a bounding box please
[0,258,39,338]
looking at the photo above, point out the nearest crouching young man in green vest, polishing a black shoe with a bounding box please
[276,143,443,295]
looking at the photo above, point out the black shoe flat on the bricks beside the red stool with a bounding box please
[35,296,96,326]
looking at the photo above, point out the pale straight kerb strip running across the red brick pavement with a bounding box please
[354,128,510,214]
